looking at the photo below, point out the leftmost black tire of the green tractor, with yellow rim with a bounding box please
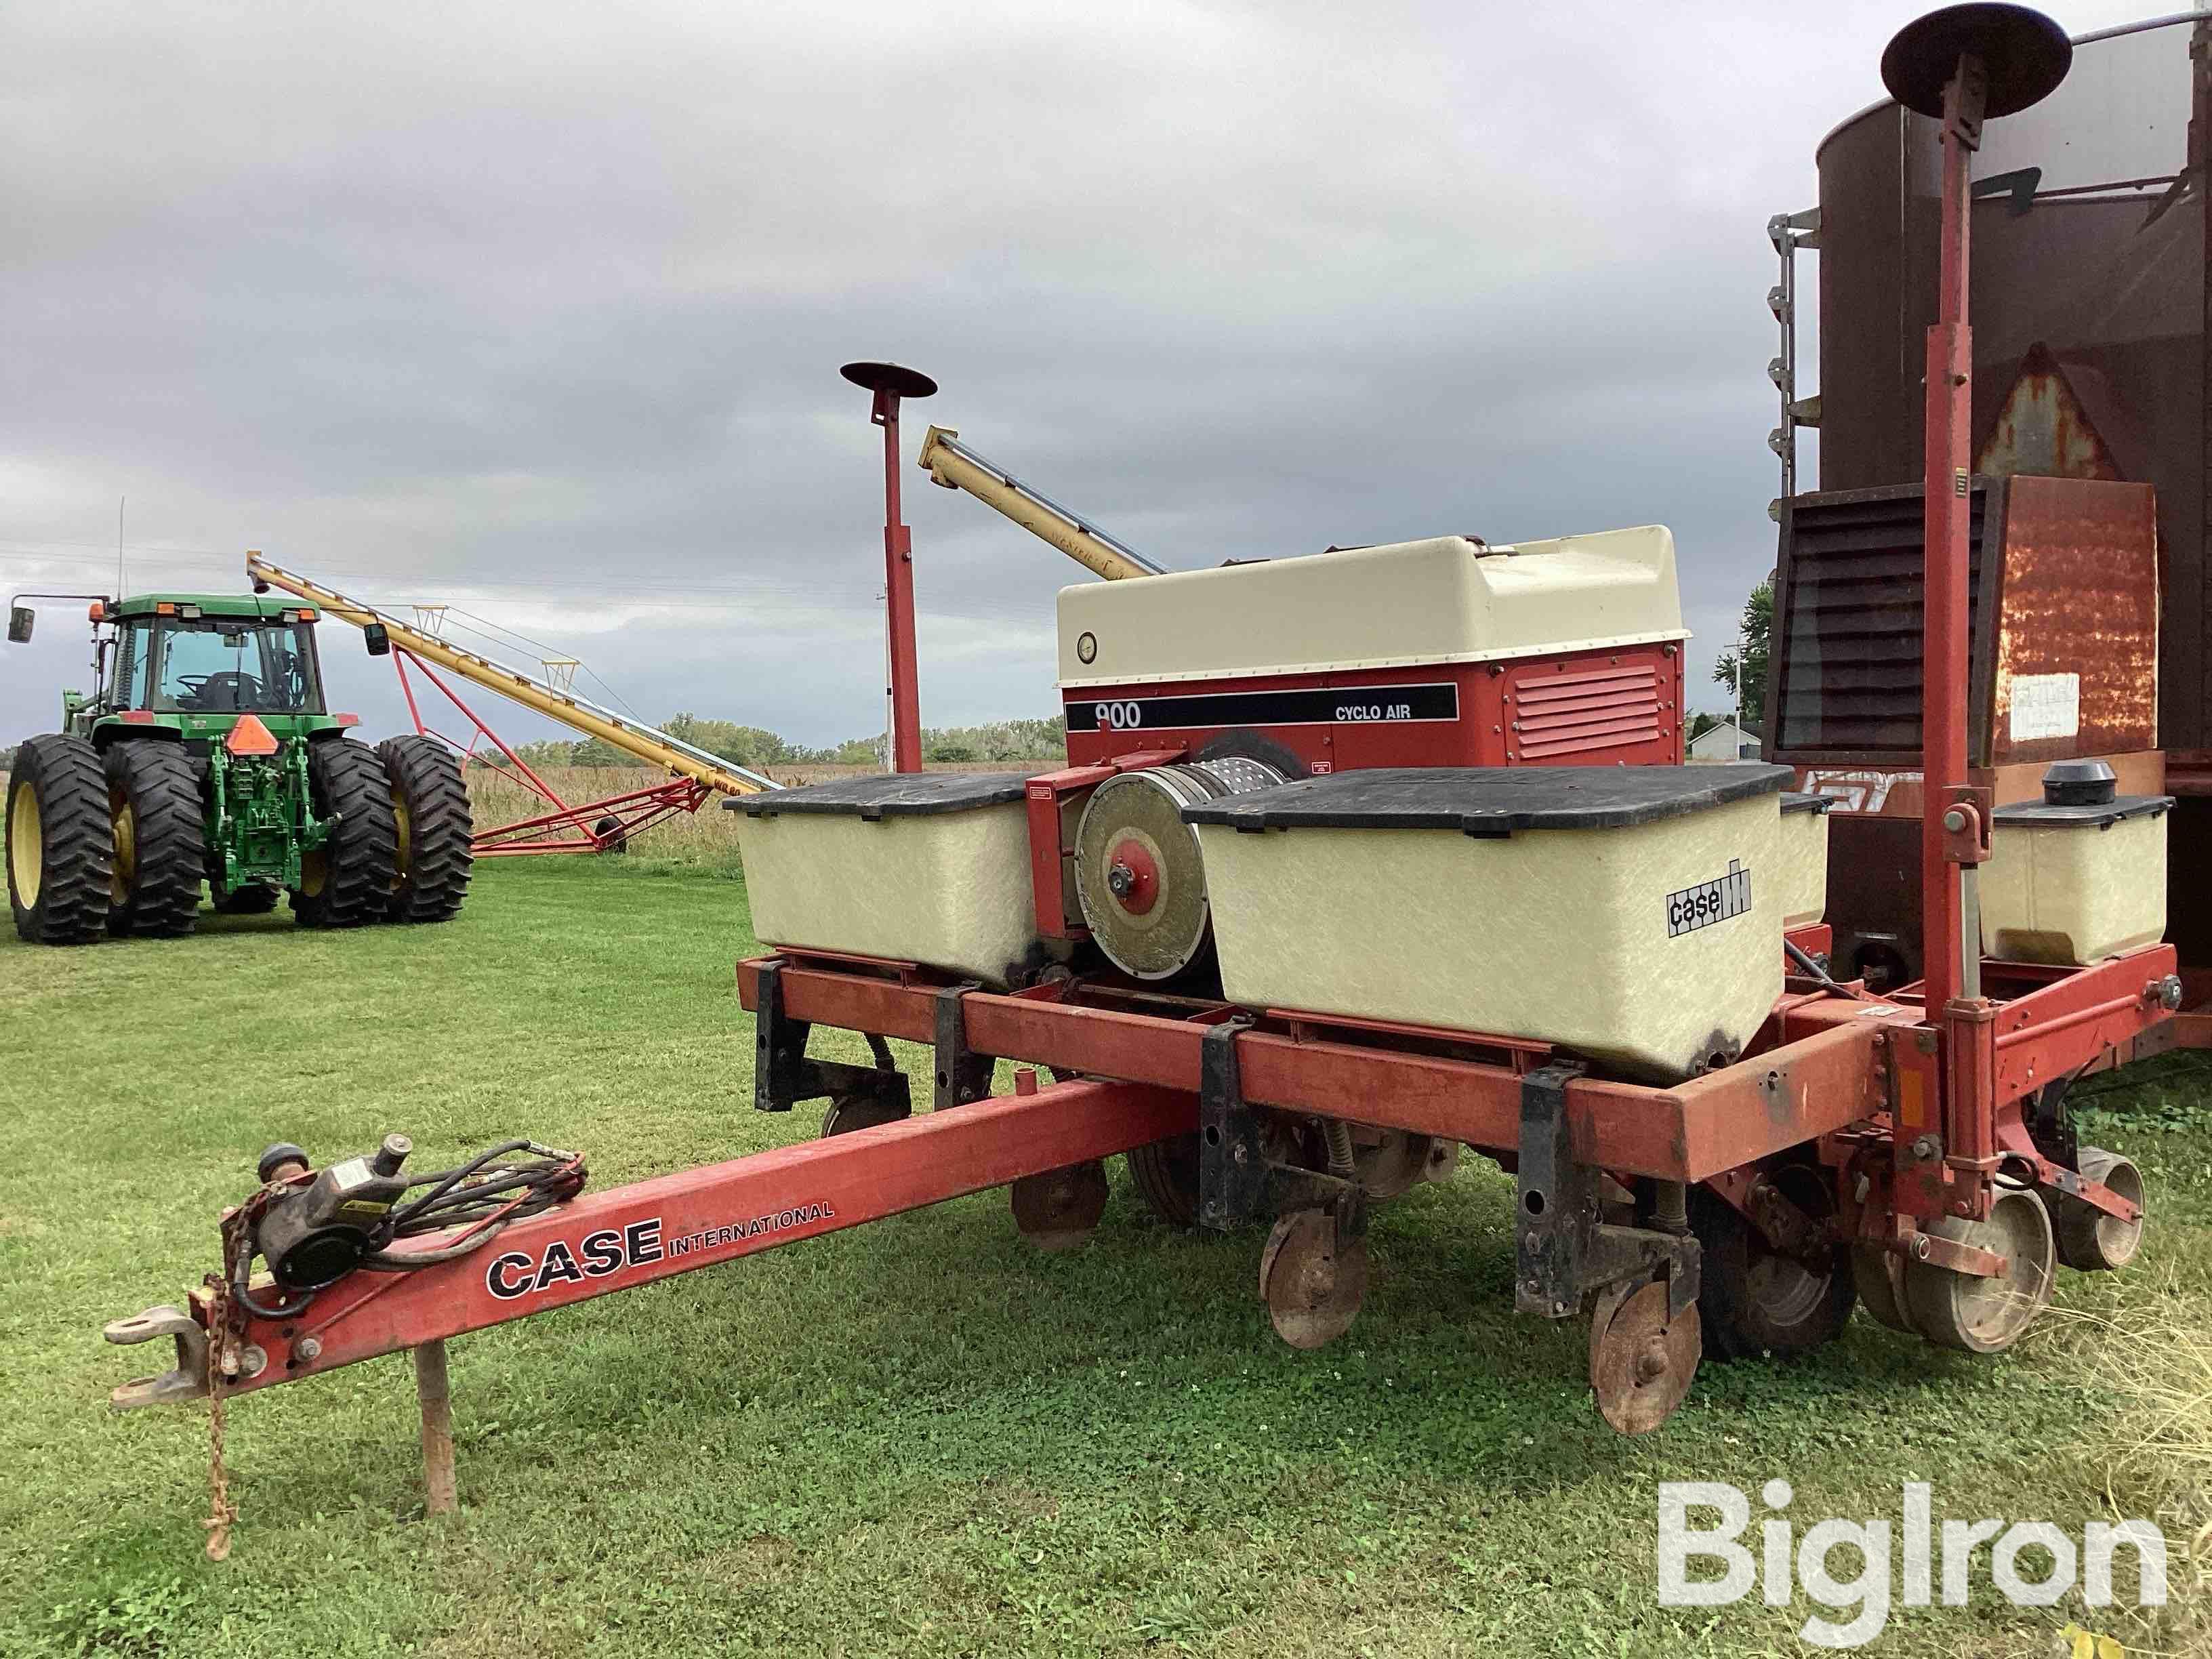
[5,732,115,945]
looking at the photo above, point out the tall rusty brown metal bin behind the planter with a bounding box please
[1767,16,2212,986]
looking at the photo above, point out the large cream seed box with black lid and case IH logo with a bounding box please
[1183,765,1792,1082]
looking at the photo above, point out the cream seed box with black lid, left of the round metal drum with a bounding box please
[737,772,1038,984]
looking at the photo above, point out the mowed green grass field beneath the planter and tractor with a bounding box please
[0,861,2212,1659]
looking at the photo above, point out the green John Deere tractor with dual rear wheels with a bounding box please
[7,593,471,945]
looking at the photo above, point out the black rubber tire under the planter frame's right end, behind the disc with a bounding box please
[1690,1164,1858,1360]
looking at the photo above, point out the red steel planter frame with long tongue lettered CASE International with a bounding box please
[142,945,2212,1425]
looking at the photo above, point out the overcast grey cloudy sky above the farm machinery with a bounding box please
[0,0,2152,743]
